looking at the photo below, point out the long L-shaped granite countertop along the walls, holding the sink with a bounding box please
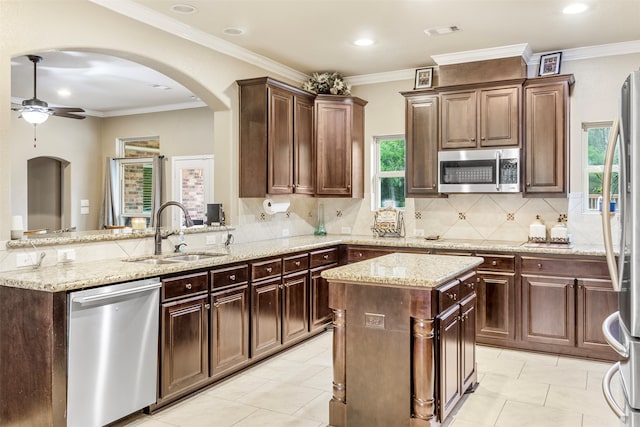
[0,235,604,292]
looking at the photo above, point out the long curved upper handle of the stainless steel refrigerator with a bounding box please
[601,118,620,292]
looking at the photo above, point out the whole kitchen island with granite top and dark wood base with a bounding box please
[322,253,483,427]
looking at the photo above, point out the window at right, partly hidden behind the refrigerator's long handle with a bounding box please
[582,122,619,213]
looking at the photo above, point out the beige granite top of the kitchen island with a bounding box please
[322,253,483,288]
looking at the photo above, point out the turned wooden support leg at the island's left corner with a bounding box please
[329,283,347,427]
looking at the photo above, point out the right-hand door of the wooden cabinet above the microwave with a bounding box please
[479,87,520,147]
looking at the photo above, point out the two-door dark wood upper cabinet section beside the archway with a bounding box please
[237,77,315,197]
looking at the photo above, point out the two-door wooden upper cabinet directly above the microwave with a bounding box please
[440,82,522,150]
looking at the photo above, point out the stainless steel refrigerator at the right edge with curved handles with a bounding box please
[602,70,640,426]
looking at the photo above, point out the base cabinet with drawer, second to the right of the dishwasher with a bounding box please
[210,264,250,377]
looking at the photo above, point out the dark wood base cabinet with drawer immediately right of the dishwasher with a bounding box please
[159,273,210,400]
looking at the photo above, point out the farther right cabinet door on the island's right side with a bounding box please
[460,293,477,392]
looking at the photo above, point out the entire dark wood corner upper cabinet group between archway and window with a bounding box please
[237,77,367,198]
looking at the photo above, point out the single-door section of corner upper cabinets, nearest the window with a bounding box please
[315,95,367,198]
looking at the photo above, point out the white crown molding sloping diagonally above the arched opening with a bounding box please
[89,0,309,83]
